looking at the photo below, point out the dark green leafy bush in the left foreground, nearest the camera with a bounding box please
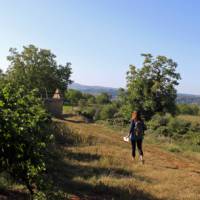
[0,85,52,193]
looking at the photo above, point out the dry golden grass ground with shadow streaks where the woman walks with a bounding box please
[1,111,200,200]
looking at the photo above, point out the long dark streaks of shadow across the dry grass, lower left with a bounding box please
[39,142,162,200]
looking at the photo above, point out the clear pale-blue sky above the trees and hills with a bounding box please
[0,0,200,94]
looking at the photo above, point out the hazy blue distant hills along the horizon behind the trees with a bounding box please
[69,83,200,104]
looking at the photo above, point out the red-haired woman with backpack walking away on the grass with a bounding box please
[127,111,145,164]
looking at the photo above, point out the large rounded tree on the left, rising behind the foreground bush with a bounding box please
[7,45,72,96]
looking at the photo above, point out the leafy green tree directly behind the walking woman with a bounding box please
[126,54,180,118]
